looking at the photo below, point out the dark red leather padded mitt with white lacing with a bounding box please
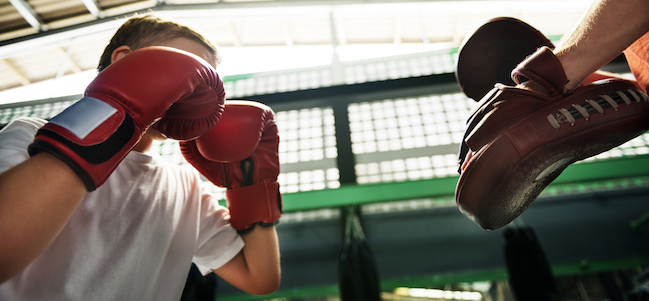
[455,47,649,229]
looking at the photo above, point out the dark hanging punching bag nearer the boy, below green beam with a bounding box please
[338,207,381,301]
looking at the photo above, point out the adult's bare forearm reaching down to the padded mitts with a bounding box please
[554,0,649,90]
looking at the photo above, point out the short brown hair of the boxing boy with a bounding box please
[97,14,219,72]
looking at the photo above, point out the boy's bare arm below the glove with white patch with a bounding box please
[0,153,86,283]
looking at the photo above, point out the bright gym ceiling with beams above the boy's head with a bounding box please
[0,0,589,95]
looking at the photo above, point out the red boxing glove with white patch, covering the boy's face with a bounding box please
[29,47,225,191]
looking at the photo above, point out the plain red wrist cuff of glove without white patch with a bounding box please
[225,182,283,233]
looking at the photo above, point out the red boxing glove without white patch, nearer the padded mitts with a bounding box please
[180,101,282,233]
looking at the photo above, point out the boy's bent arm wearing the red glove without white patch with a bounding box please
[180,101,282,294]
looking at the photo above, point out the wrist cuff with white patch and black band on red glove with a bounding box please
[28,97,143,191]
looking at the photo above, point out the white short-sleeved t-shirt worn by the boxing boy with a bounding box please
[0,118,243,301]
